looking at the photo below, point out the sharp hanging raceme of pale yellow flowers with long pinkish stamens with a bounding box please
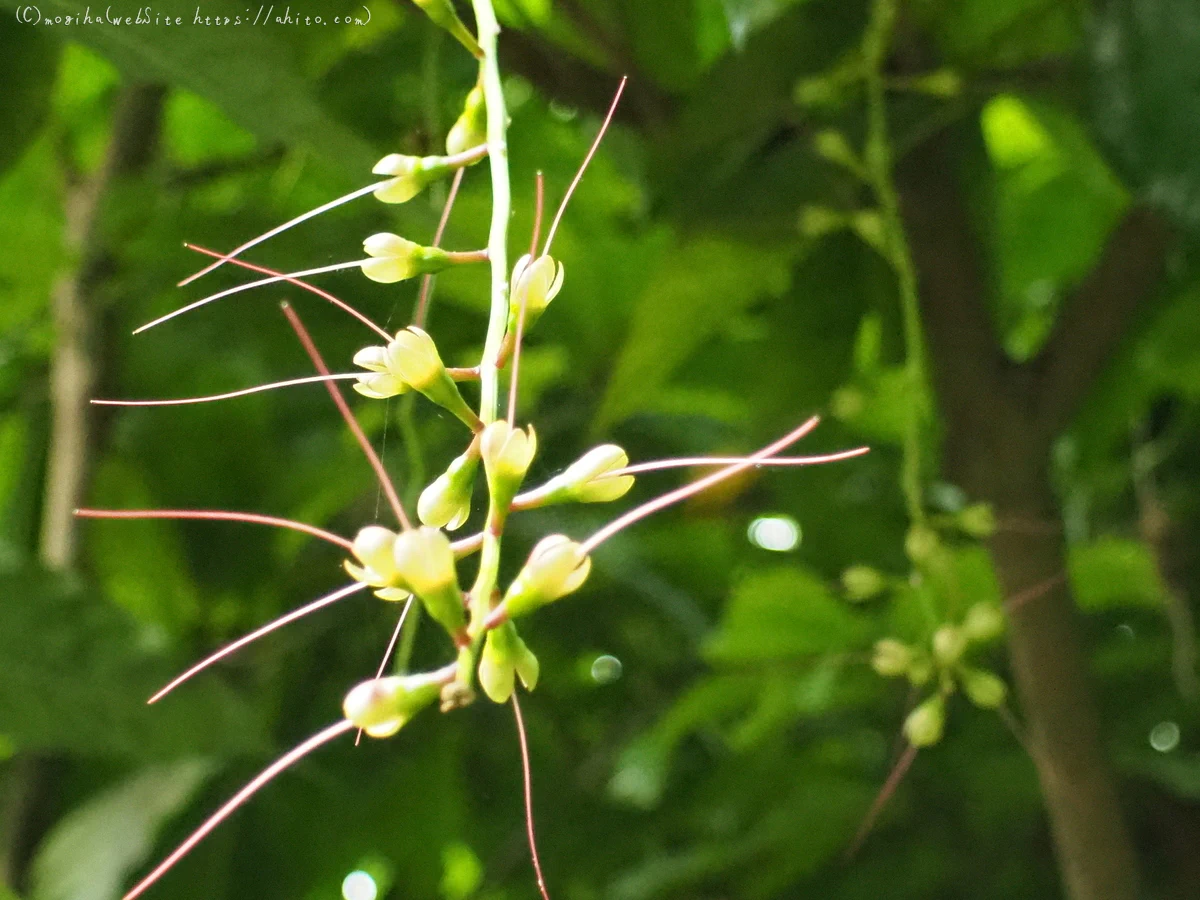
[84,10,873,900]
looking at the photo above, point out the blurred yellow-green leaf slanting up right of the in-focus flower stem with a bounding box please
[596,232,792,428]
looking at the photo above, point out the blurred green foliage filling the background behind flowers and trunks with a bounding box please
[0,0,1200,900]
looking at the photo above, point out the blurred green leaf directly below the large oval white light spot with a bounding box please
[704,568,870,662]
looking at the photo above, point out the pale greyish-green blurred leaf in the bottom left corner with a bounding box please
[30,760,212,900]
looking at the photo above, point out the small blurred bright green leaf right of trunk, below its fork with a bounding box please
[1068,538,1164,612]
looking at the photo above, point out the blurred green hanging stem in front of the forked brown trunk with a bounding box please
[863,0,925,524]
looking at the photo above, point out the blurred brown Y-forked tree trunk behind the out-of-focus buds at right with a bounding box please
[898,118,1142,900]
